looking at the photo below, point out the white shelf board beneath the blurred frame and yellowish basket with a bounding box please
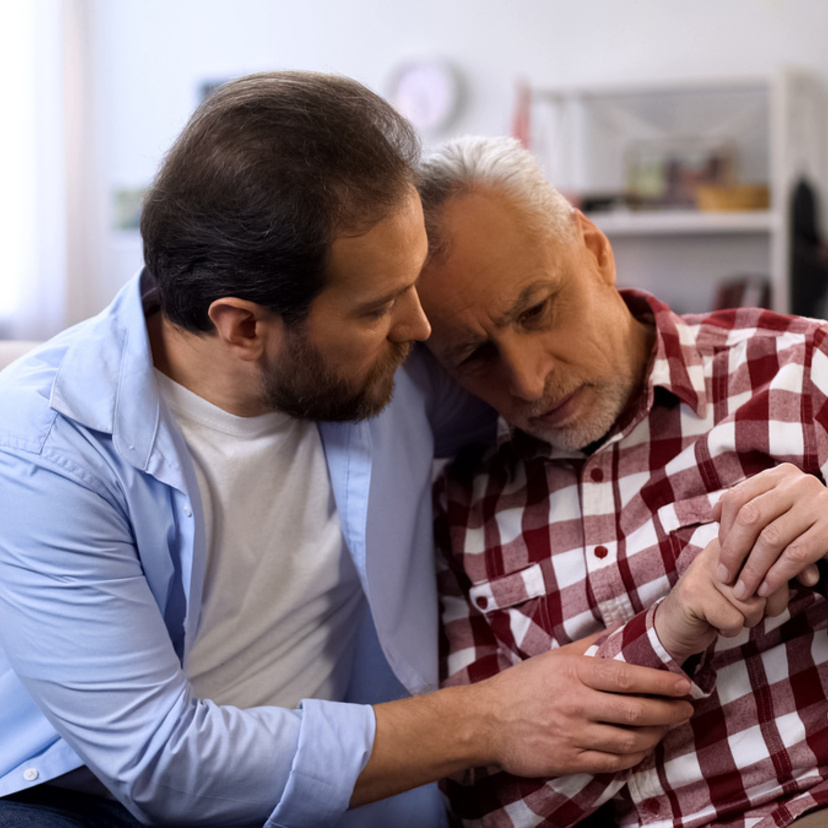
[589,210,782,236]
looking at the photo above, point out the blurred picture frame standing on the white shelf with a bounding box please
[625,138,736,209]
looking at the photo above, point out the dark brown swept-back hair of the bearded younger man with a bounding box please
[141,72,420,331]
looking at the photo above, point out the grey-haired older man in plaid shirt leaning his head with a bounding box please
[419,139,828,828]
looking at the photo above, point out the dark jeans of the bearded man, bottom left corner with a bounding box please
[0,785,141,828]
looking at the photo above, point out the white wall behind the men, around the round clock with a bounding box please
[79,0,828,326]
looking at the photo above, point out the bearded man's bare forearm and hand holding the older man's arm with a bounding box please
[351,642,692,807]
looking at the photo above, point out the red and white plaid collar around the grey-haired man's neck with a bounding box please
[497,289,707,460]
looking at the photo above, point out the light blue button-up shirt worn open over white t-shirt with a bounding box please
[0,277,488,828]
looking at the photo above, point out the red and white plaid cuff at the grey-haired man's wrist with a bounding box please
[587,599,716,699]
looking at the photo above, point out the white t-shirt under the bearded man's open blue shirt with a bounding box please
[155,371,365,707]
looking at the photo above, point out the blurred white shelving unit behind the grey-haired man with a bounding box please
[531,69,828,313]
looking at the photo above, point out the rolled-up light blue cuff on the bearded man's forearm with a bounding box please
[265,699,376,828]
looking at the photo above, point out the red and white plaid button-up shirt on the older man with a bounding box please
[436,291,828,828]
